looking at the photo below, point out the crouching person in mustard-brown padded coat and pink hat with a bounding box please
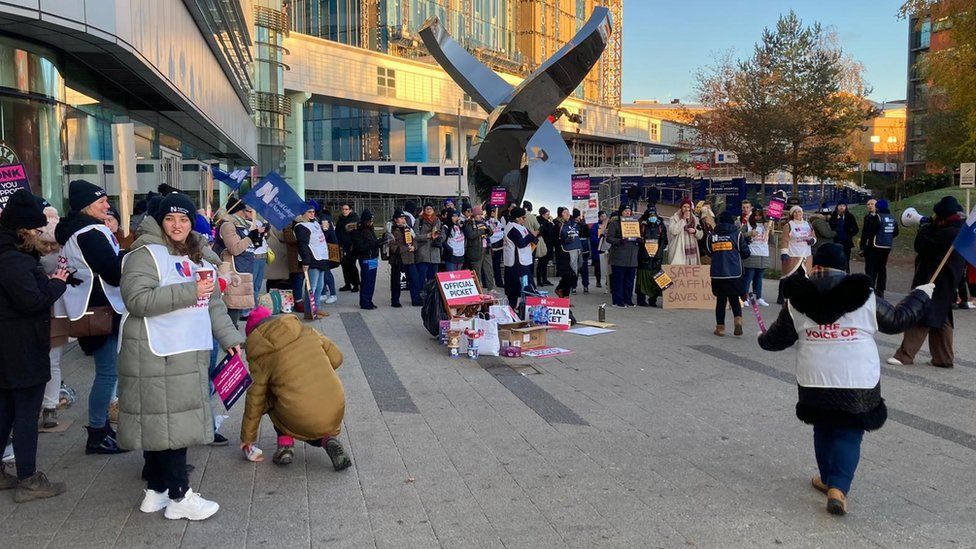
[241,307,352,471]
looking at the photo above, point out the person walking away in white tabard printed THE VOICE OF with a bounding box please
[759,243,933,515]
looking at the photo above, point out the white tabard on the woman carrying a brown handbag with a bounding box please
[54,225,125,320]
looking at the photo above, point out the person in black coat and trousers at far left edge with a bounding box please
[0,189,68,503]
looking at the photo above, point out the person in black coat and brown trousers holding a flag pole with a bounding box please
[888,196,966,368]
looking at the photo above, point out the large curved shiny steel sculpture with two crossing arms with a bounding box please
[420,7,611,210]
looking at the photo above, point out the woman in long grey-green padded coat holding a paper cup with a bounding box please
[119,193,244,520]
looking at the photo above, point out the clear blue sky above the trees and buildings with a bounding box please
[623,0,908,103]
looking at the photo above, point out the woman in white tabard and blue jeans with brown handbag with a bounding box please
[54,179,125,454]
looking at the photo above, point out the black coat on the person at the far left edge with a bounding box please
[0,229,65,389]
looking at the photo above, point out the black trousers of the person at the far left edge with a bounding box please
[0,383,45,480]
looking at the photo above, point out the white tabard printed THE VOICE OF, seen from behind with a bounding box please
[790,296,881,389]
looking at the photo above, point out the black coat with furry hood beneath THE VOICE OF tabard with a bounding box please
[759,270,929,431]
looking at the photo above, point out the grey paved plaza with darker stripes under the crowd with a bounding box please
[0,271,976,549]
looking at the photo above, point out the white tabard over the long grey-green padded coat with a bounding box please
[119,244,217,356]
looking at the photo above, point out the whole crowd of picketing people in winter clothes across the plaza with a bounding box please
[0,180,976,520]
